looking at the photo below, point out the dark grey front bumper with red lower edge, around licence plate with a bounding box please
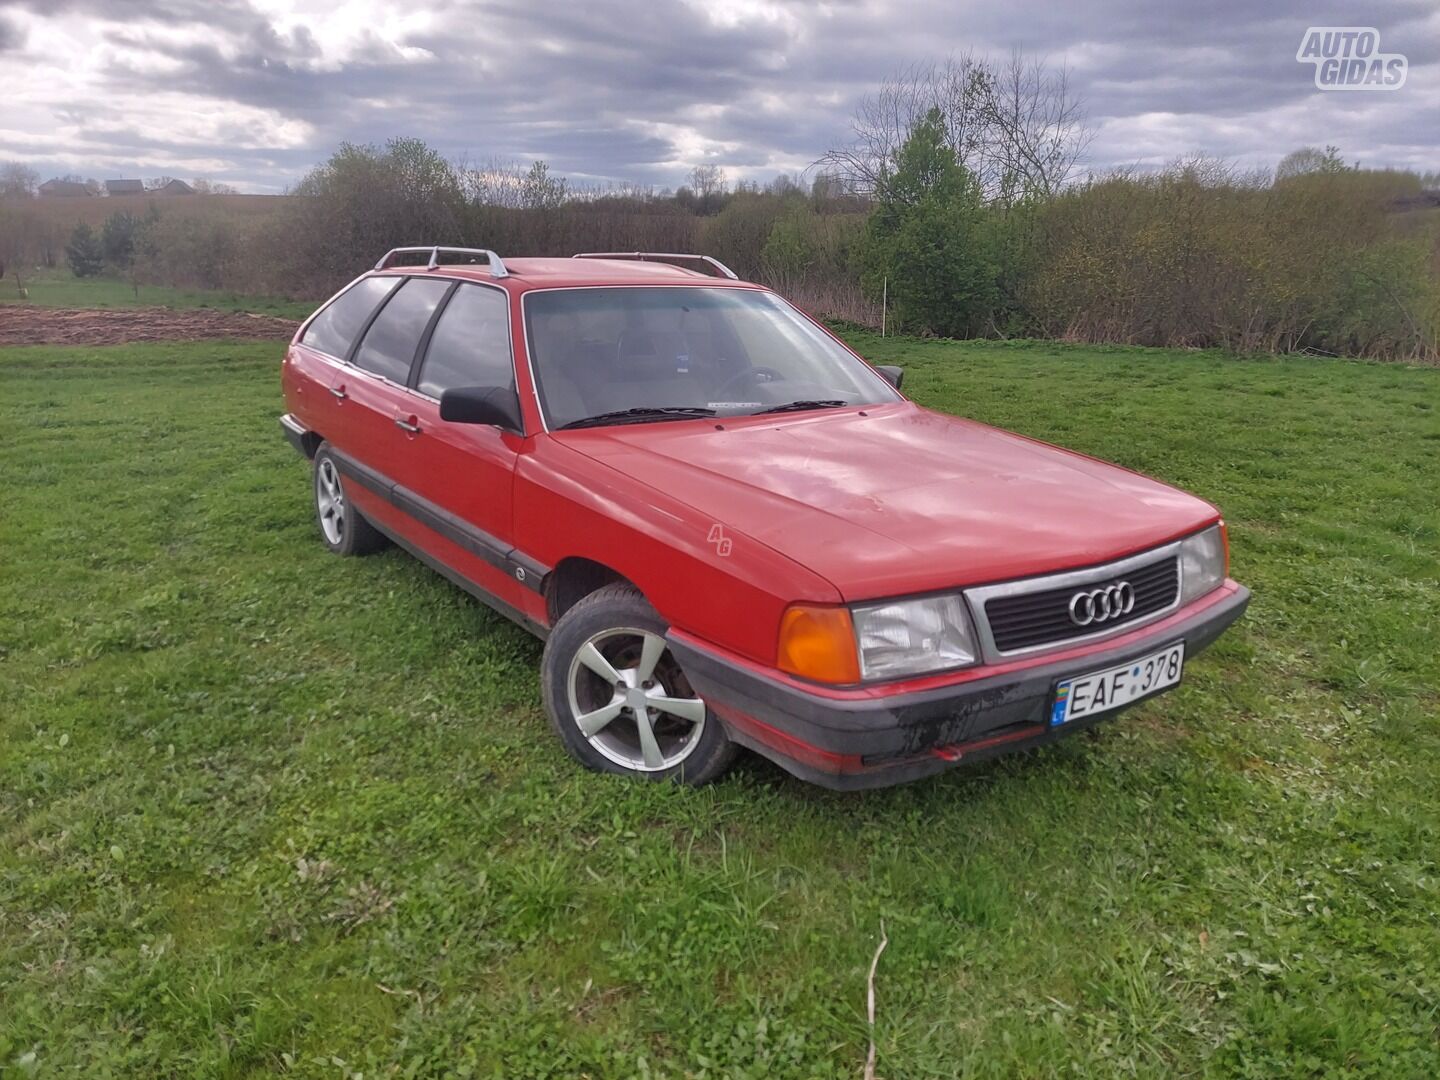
[670,580,1250,789]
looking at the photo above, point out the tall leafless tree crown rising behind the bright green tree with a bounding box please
[818,52,1093,200]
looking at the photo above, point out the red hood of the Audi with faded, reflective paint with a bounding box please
[556,403,1218,600]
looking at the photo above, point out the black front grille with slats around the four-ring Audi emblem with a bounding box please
[985,556,1179,652]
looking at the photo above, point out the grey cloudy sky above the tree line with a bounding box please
[0,0,1440,192]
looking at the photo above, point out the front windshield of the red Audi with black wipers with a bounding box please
[524,285,899,428]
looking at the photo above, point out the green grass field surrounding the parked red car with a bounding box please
[0,338,1440,1080]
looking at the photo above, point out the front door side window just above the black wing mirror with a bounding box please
[416,285,516,397]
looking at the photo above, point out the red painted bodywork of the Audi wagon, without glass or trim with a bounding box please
[282,259,1244,775]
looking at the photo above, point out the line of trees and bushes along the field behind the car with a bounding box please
[0,55,1440,360]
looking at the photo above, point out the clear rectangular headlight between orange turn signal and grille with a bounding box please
[851,595,979,680]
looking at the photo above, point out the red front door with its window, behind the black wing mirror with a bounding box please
[393,282,539,608]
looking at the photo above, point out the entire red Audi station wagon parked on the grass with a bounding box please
[281,248,1250,788]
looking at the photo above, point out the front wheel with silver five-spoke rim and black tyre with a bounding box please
[541,583,736,786]
